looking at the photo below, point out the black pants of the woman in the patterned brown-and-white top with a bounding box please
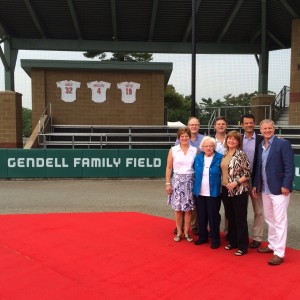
[222,186,249,252]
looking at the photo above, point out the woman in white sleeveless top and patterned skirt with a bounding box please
[166,127,197,242]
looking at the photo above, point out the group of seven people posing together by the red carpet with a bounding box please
[166,114,295,265]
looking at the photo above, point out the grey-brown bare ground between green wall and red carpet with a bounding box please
[0,179,300,250]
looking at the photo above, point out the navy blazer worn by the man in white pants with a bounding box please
[253,136,295,195]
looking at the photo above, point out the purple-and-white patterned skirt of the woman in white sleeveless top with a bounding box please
[168,174,195,211]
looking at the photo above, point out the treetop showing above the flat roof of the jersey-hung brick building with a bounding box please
[83,51,153,62]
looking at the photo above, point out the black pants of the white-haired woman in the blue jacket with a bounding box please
[195,196,221,246]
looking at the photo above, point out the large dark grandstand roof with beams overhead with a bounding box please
[0,0,300,54]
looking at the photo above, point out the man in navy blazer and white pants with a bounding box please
[252,119,295,266]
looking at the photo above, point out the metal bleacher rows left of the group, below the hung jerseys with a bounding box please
[38,125,177,149]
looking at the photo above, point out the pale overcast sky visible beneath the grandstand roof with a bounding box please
[0,49,290,108]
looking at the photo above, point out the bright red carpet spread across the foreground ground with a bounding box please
[0,213,300,300]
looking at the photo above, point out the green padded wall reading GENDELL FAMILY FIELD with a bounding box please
[0,149,300,190]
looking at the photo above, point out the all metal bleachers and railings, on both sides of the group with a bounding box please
[33,94,300,154]
